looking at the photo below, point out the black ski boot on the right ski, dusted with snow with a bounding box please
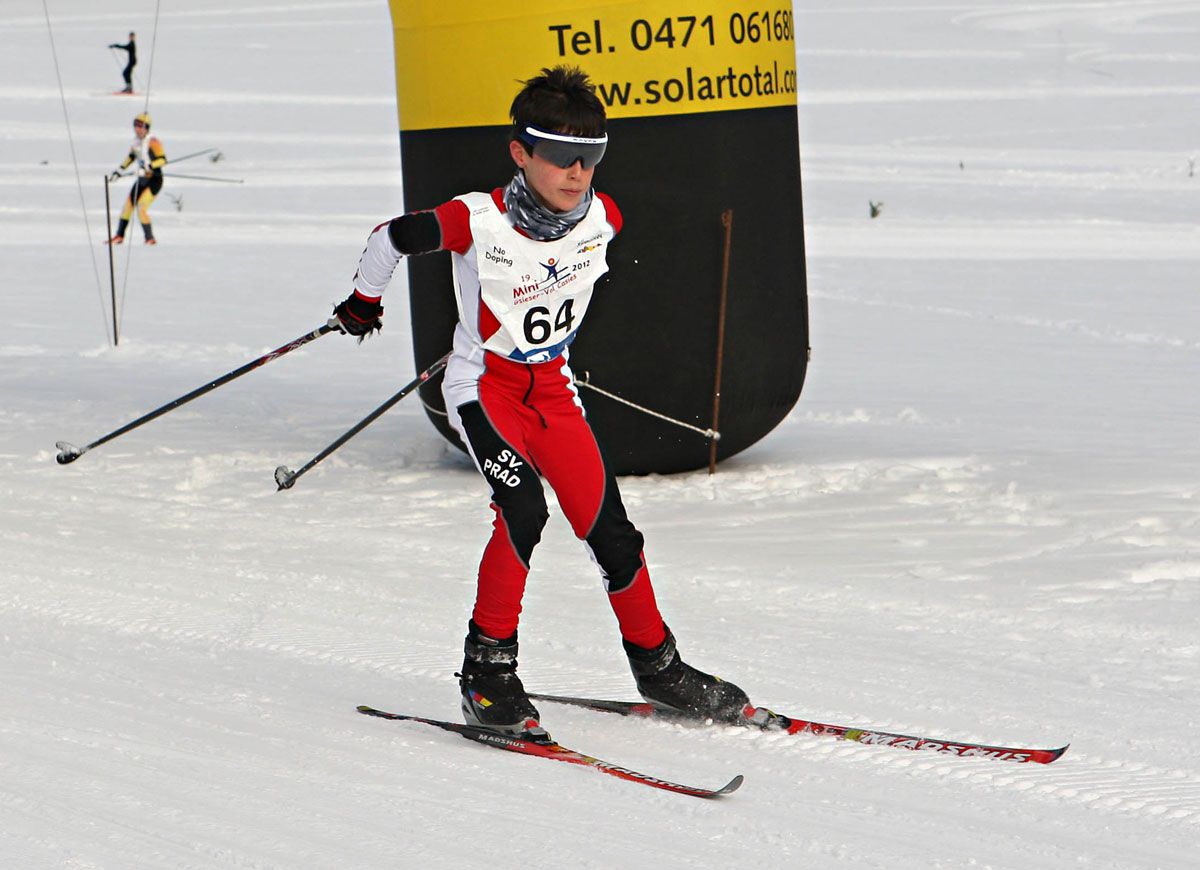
[622,629,750,722]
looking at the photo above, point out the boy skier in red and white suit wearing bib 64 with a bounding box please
[335,66,749,734]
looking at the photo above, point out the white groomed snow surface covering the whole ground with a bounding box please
[0,0,1200,870]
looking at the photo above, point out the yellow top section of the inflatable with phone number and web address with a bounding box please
[390,0,796,130]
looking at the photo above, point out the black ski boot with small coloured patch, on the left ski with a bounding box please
[457,620,546,739]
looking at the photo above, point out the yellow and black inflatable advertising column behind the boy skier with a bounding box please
[391,0,809,474]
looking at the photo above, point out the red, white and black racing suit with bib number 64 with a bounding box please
[354,190,666,649]
